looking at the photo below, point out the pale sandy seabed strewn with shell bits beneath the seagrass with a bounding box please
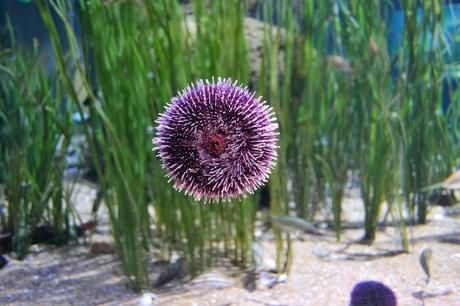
[0,185,460,306]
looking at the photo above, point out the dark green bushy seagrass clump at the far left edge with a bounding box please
[0,43,76,258]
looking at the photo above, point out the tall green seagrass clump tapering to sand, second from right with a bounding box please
[334,2,398,242]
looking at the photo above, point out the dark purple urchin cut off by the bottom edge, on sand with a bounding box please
[350,281,397,306]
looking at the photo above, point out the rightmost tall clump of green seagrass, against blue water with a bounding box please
[397,0,456,223]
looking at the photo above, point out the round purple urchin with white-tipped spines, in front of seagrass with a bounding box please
[153,78,278,201]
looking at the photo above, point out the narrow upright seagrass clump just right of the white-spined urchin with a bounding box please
[257,1,293,271]
